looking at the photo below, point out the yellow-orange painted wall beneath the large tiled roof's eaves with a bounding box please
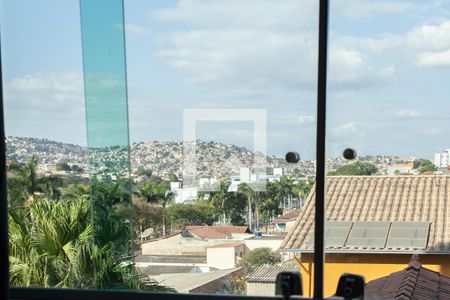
[297,254,450,296]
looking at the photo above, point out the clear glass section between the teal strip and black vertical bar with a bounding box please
[125,0,318,296]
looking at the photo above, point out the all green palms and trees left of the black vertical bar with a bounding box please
[8,159,312,291]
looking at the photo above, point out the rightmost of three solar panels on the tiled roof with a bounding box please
[386,221,430,249]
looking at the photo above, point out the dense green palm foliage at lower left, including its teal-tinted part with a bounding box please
[8,159,173,291]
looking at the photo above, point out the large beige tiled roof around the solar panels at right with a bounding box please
[281,175,450,253]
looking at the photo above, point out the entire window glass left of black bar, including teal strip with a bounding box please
[1,0,320,296]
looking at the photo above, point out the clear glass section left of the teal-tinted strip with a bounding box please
[1,1,89,288]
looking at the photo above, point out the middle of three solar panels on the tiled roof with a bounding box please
[345,221,391,247]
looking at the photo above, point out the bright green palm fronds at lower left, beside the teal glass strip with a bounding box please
[9,198,92,287]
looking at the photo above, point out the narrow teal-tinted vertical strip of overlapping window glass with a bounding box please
[80,0,135,289]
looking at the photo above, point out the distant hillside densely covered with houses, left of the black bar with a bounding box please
[6,137,314,178]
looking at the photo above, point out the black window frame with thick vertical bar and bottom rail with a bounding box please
[0,0,329,300]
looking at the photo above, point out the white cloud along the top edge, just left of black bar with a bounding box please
[151,0,319,30]
